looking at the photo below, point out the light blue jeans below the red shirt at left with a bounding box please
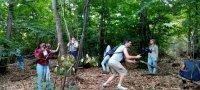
[36,63,53,90]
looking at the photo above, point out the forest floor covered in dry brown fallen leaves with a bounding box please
[0,60,199,90]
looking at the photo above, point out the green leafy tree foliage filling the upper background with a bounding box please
[0,0,200,61]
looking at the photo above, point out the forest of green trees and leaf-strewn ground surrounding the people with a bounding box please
[0,0,200,90]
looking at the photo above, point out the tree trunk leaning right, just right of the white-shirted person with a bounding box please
[77,0,89,64]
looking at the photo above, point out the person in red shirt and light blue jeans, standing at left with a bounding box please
[34,42,52,90]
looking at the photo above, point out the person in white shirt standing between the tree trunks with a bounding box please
[67,36,78,59]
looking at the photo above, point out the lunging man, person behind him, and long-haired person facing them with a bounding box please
[101,39,158,90]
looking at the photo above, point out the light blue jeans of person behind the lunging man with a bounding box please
[101,55,110,72]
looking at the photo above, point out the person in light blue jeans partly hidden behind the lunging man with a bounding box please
[101,42,111,74]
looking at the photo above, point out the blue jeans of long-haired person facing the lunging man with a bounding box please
[148,56,157,74]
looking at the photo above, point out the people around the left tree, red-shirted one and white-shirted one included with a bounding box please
[34,37,78,90]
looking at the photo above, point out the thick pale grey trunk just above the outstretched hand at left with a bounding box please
[52,0,66,56]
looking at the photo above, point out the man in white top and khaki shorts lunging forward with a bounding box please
[102,40,141,90]
